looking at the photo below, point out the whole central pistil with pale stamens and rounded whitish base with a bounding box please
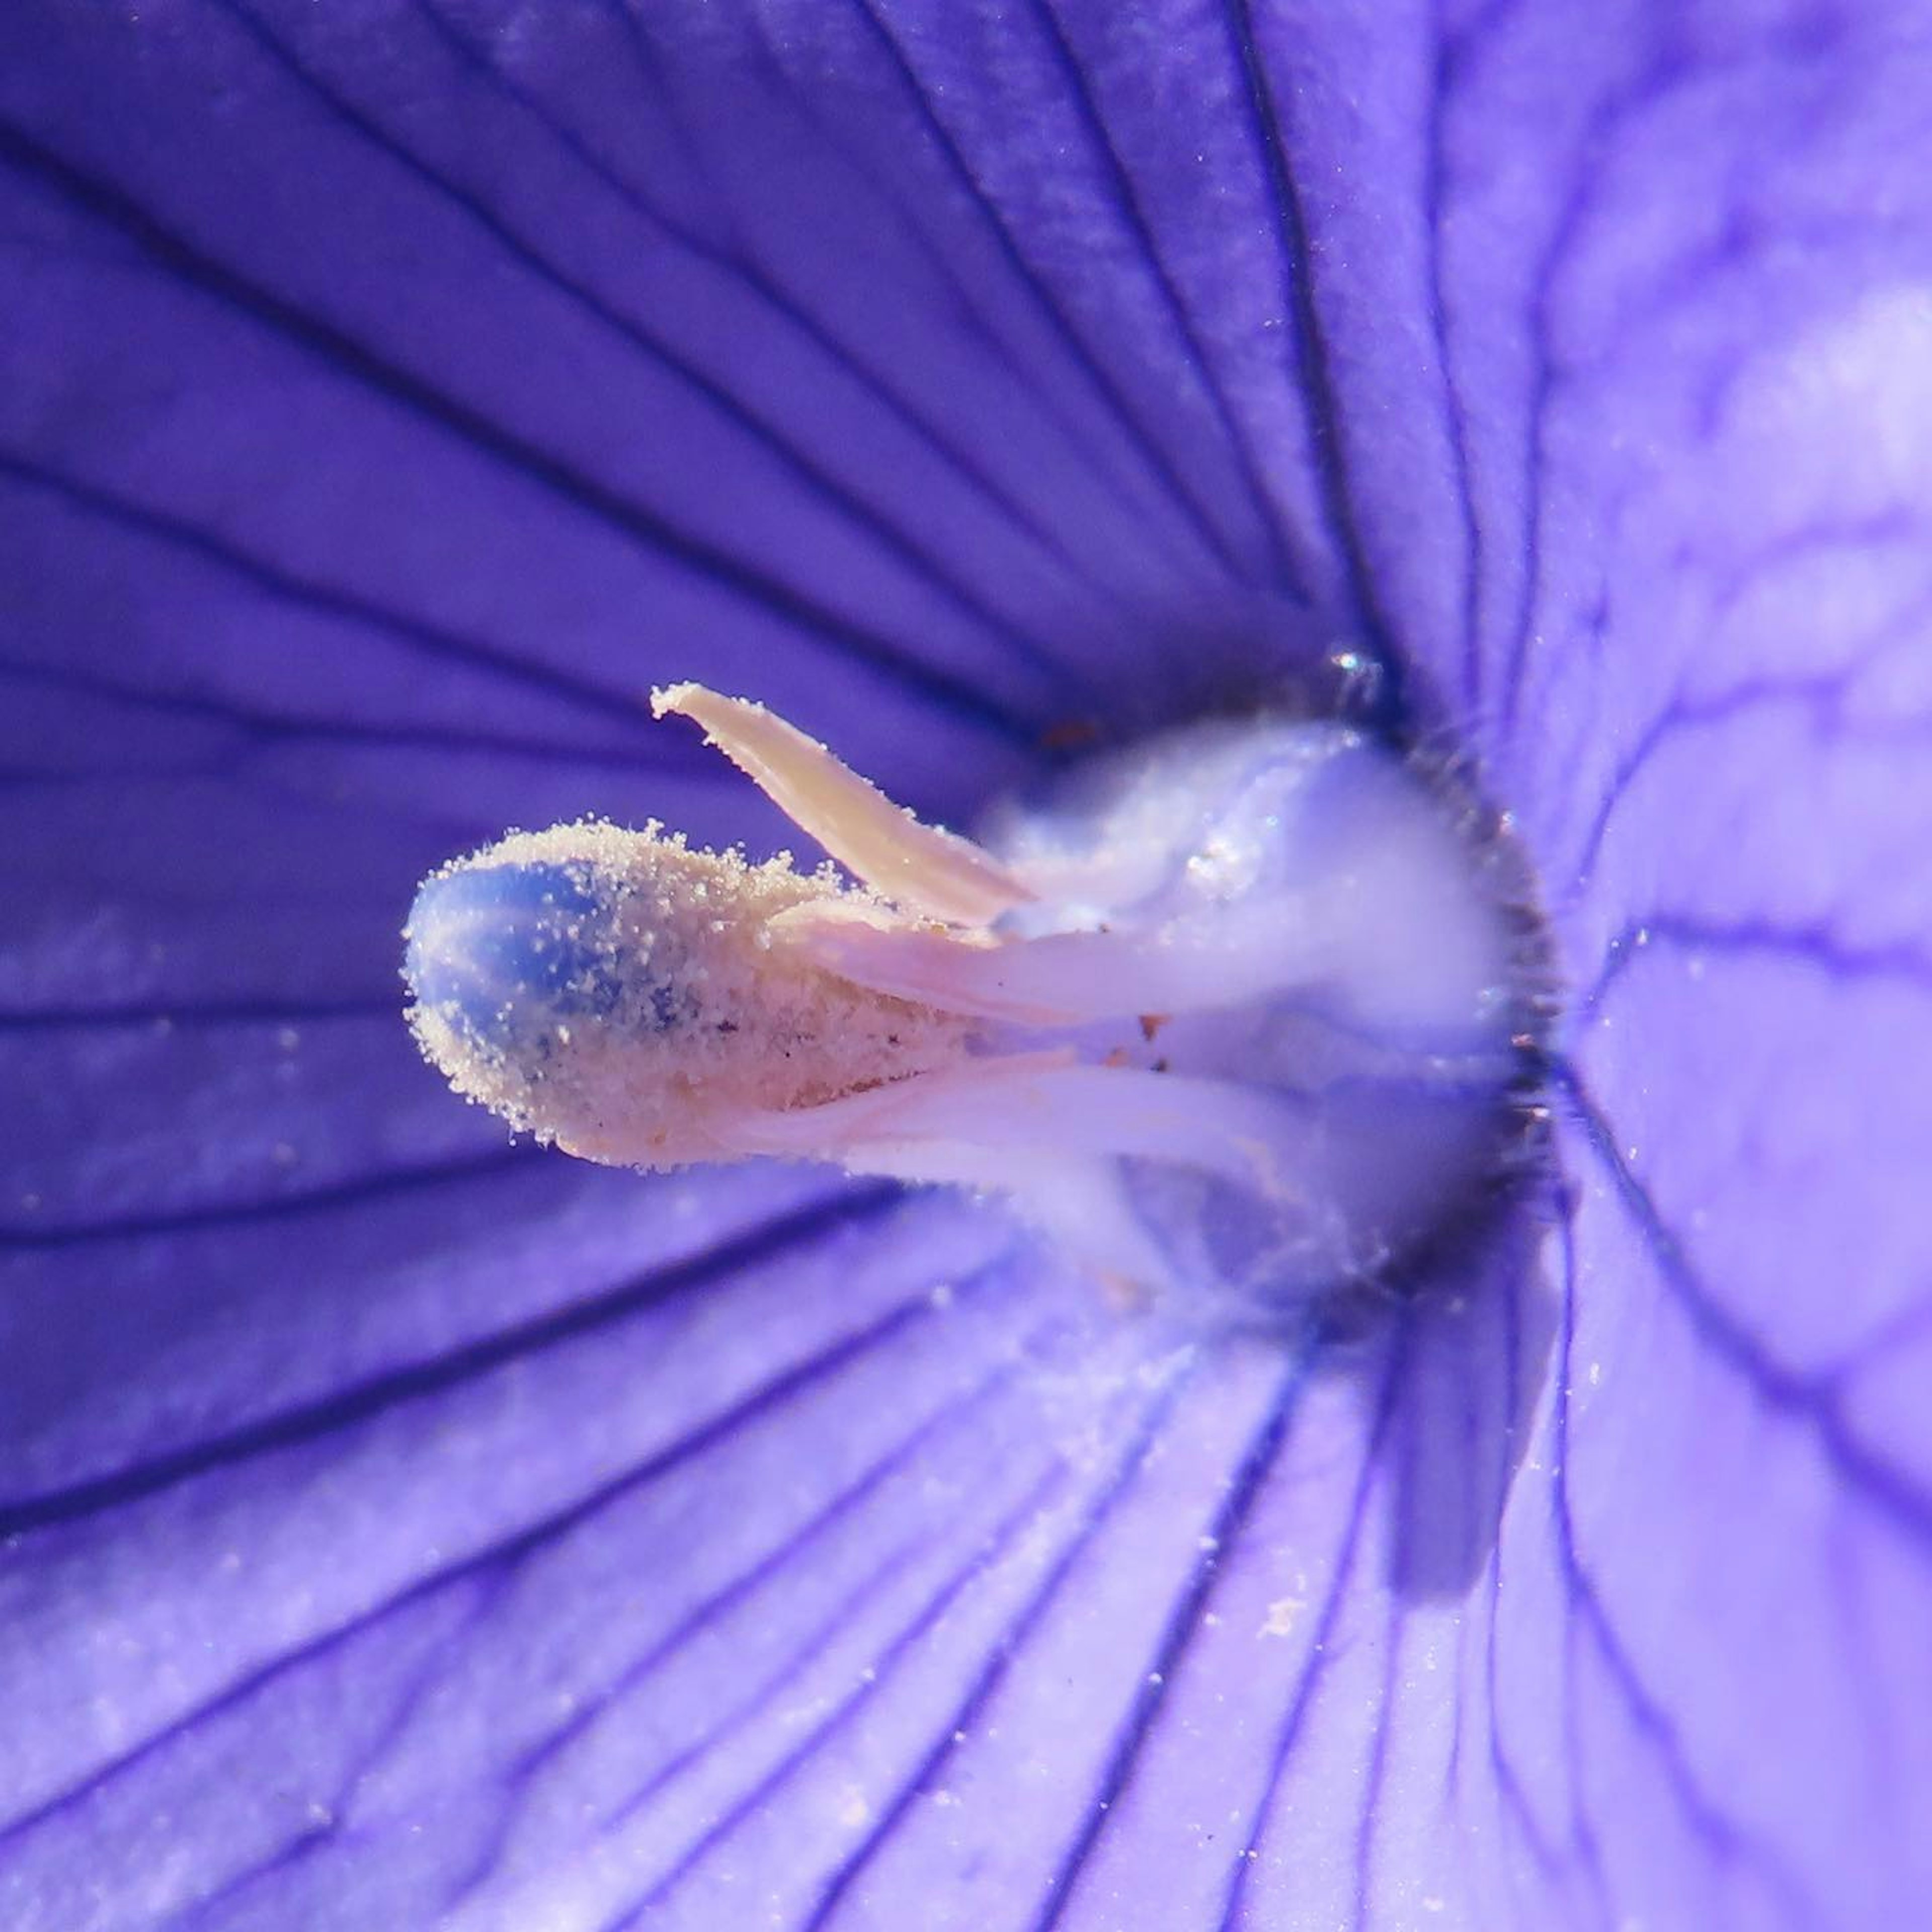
[404,684,1530,1297]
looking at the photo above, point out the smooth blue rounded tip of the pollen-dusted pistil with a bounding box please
[404,863,624,1047]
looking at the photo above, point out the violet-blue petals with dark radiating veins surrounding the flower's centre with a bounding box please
[0,0,1932,1932]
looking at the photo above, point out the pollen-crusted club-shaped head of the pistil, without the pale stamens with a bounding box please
[404,821,968,1167]
